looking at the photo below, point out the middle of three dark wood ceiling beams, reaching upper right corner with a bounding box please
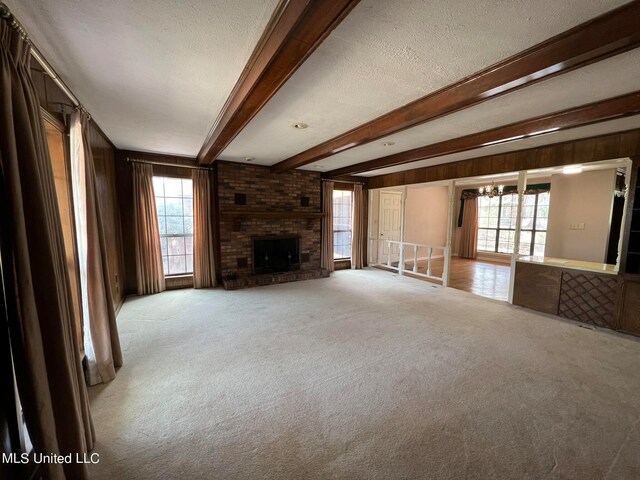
[271,0,640,173]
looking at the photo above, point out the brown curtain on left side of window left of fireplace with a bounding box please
[133,163,165,295]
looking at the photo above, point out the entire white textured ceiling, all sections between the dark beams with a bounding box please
[5,0,640,176]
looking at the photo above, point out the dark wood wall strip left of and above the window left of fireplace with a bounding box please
[115,150,197,295]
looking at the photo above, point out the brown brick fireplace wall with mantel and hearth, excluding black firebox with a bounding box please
[217,161,328,289]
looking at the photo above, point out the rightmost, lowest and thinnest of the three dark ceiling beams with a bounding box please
[323,91,640,178]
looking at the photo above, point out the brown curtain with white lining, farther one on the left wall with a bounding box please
[71,111,122,385]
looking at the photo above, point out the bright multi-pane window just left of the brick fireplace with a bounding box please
[153,177,193,276]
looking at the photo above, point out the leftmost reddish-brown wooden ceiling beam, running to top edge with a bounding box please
[198,0,359,164]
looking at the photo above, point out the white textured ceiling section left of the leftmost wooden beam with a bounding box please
[5,0,277,156]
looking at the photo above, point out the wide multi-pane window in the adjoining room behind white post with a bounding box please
[478,192,550,256]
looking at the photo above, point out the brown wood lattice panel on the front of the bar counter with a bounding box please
[558,270,619,328]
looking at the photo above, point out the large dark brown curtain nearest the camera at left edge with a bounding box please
[0,16,94,479]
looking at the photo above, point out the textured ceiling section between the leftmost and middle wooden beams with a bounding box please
[221,0,626,165]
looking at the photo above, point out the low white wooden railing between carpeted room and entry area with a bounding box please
[369,238,447,281]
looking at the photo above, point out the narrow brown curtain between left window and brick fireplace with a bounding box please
[193,170,216,288]
